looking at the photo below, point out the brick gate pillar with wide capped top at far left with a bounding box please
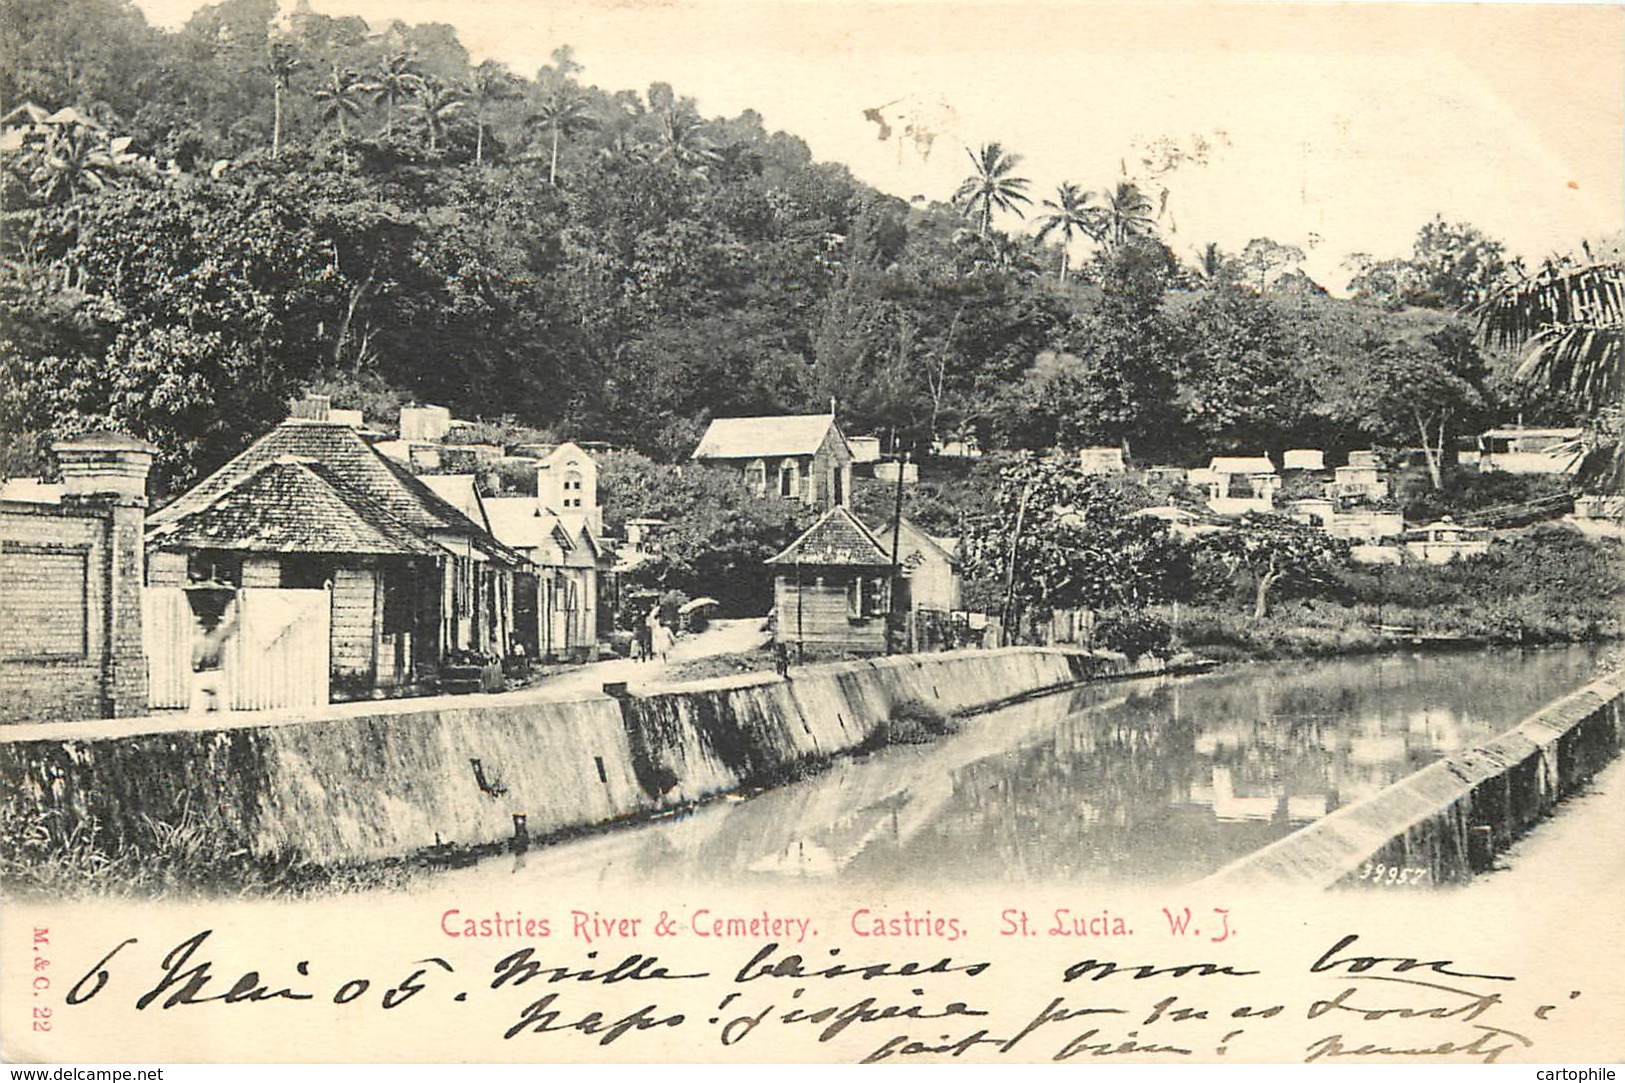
[50,433,158,717]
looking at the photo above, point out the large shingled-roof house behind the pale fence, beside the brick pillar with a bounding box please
[146,418,523,693]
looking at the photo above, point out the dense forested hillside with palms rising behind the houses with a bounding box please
[0,0,1562,486]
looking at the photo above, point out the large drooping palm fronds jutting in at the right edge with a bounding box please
[1472,262,1625,416]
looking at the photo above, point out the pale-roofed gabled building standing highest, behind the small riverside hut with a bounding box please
[692,413,853,509]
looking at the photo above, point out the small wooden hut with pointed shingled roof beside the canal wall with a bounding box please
[767,506,897,652]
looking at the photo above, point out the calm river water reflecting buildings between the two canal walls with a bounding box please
[449,647,1599,888]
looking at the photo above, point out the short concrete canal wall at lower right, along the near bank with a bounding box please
[1204,673,1625,889]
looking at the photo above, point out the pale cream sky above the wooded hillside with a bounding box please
[137,0,1625,289]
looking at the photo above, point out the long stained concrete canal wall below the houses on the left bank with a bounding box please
[0,647,1160,865]
